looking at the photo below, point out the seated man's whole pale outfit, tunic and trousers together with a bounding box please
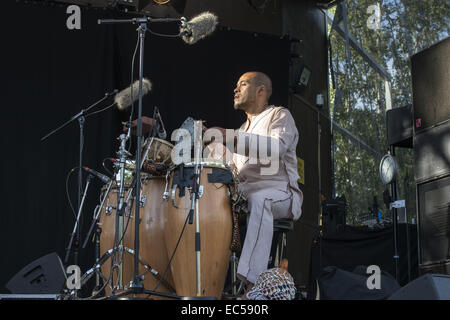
[233,106,303,283]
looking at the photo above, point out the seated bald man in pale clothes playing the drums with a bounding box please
[205,72,303,296]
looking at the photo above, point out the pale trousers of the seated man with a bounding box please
[237,189,292,283]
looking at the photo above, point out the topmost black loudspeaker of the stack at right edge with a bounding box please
[411,37,450,133]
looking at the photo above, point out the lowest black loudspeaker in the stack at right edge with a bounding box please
[417,176,450,264]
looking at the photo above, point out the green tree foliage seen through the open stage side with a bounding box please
[330,0,450,224]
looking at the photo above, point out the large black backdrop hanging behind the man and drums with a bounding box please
[0,0,289,293]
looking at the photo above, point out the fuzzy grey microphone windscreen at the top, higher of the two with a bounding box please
[180,11,219,44]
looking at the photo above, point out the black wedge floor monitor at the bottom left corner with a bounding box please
[5,253,66,294]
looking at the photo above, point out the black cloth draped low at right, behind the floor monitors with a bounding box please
[308,223,419,299]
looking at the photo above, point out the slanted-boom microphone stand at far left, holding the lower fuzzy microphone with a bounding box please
[41,90,117,265]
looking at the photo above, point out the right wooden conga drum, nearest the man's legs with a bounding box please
[164,162,233,299]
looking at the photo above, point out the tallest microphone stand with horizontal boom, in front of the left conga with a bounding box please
[98,17,180,299]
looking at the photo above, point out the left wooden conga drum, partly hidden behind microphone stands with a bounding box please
[99,173,175,299]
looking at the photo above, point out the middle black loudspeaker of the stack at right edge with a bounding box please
[414,121,450,183]
